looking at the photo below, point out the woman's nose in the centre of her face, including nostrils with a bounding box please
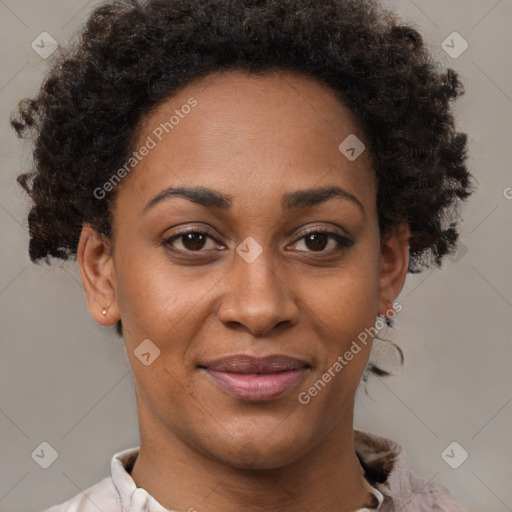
[217,250,299,336]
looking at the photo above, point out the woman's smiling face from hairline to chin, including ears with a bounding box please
[79,72,407,468]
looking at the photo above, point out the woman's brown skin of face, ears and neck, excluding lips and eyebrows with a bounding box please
[78,71,410,512]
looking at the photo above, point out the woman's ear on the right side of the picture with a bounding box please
[378,222,411,317]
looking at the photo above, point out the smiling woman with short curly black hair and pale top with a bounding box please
[12,0,471,512]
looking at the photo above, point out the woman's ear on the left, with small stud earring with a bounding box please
[77,224,121,326]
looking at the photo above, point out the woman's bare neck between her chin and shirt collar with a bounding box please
[131,398,371,512]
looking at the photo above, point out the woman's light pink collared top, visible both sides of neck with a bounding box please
[43,429,467,512]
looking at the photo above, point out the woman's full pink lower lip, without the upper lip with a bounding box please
[206,368,306,401]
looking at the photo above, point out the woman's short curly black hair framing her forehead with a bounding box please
[11,0,473,348]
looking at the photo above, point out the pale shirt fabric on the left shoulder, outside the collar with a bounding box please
[42,477,122,512]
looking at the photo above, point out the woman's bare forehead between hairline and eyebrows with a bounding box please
[119,71,374,211]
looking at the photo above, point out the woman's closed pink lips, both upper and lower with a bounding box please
[202,354,310,402]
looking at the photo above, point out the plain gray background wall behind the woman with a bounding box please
[0,0,512,512]
